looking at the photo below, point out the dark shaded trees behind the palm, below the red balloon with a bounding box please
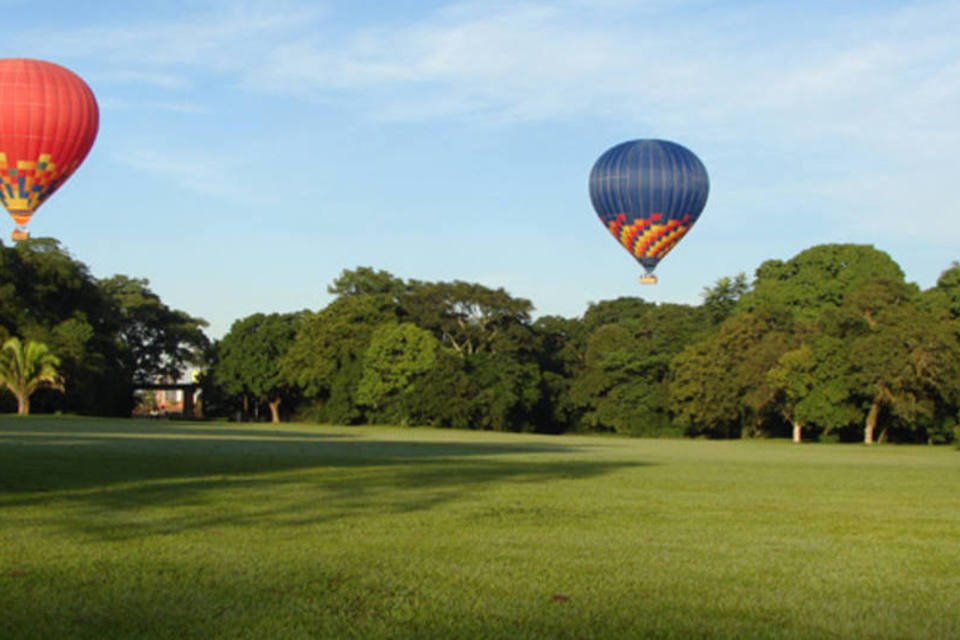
[0,238,207,415]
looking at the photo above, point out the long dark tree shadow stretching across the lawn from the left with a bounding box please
[0,422,643,539]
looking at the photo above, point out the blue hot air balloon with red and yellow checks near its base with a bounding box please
[590,140,710,284]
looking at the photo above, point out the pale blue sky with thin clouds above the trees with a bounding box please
[0,0,960,337]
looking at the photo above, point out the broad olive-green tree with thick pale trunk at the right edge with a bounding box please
[768,278,960,443]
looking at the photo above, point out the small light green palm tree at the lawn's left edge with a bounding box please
[0,338,63,416]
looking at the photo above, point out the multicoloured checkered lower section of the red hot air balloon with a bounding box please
[0,151,75,224]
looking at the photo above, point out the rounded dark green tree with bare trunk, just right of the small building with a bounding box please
[212,313,301,424]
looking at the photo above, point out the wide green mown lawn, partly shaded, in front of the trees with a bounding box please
[0,417,960,639]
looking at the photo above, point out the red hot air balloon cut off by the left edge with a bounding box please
[0,58,99,240]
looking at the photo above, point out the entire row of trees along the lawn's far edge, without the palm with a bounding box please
[0,239,960,442]
